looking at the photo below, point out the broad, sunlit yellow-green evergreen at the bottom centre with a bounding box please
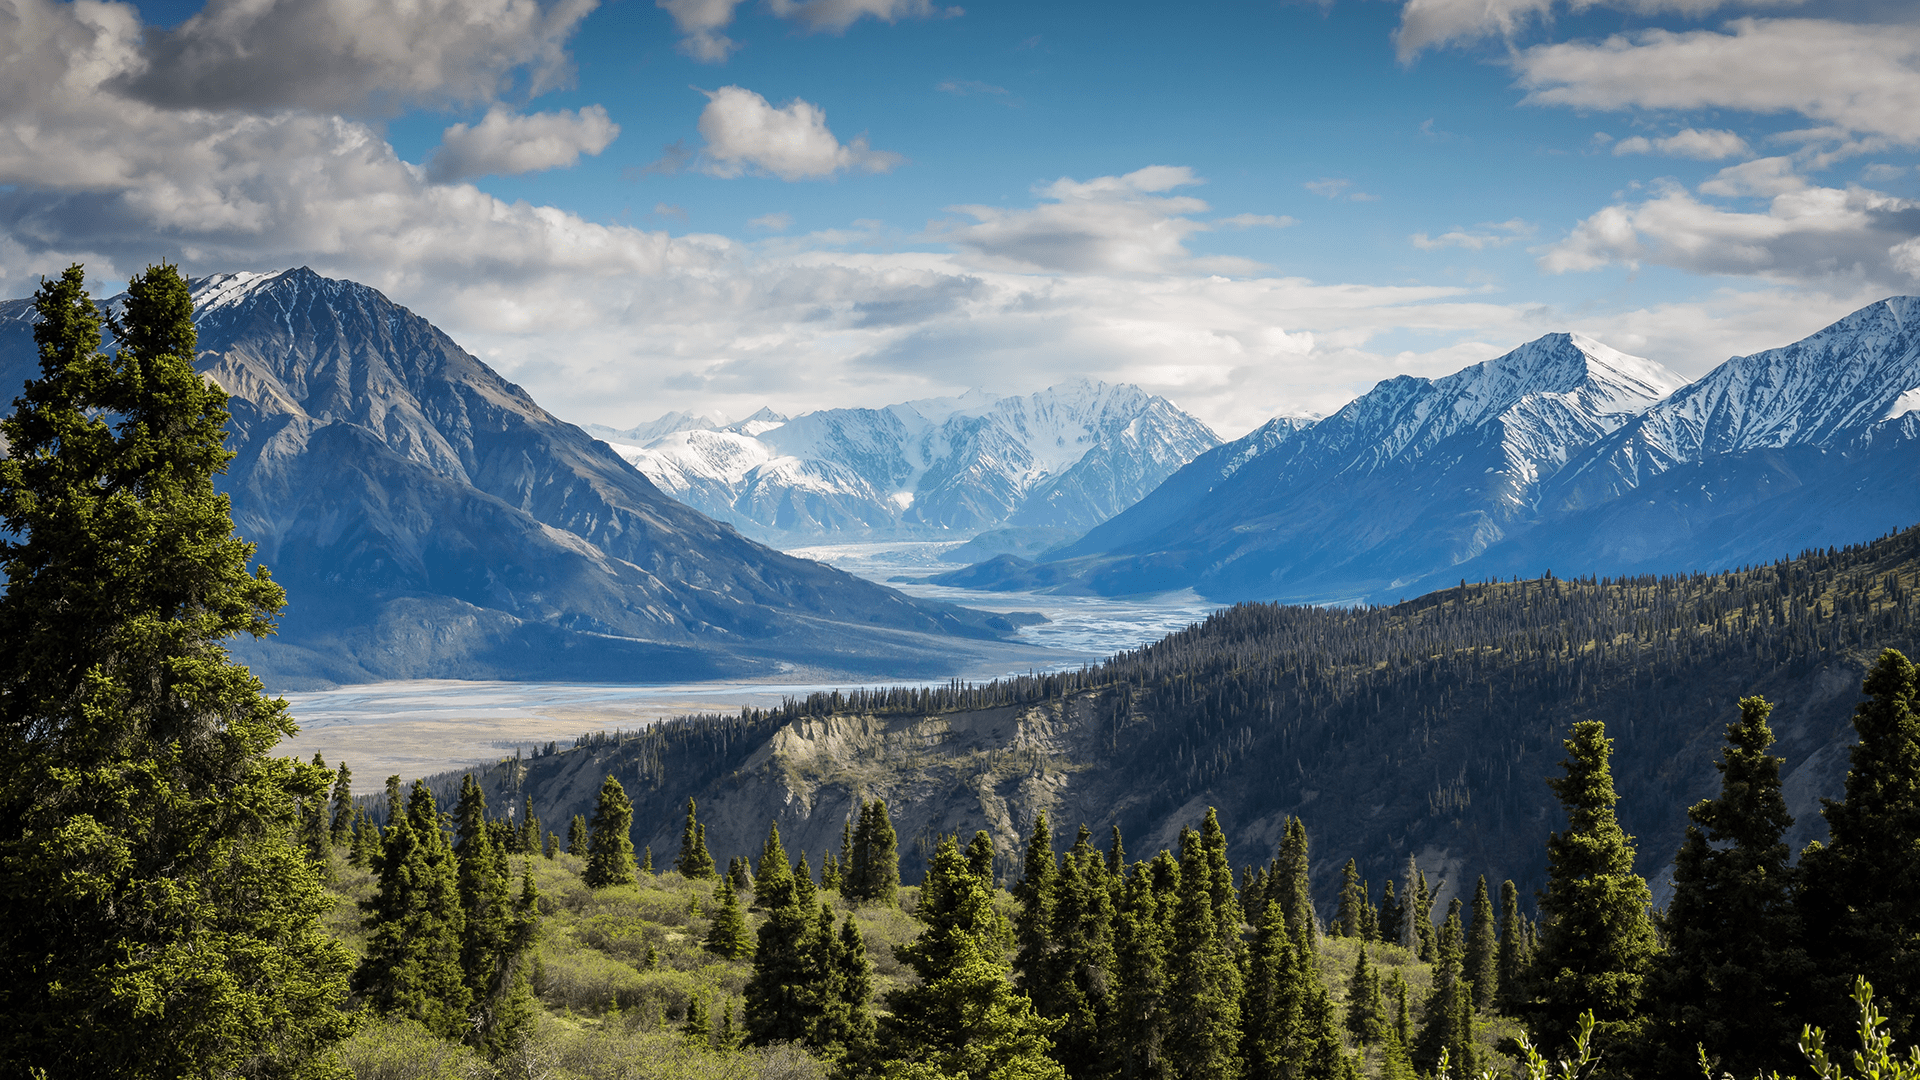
[879,838,1066,1080]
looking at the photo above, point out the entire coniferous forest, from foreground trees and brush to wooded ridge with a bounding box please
[11,267,1920,1080]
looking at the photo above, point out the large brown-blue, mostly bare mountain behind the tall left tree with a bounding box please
[0,269,1036,688]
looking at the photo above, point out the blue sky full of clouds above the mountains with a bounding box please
[0,0,1920,438]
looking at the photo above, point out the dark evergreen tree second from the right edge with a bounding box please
[1644,698,1812,1076]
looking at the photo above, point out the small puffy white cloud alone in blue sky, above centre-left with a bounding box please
[683,86,906,181]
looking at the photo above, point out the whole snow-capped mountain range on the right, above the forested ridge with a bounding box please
[931,296,1920,601]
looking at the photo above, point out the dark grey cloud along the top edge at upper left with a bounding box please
[123,0,597,113]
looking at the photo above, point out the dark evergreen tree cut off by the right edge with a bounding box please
[1801,650,1920,1043]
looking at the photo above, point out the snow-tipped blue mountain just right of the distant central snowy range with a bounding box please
[1048,334,1684,601]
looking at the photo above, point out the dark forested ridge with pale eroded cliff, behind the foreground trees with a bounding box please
[436,528,1920,913]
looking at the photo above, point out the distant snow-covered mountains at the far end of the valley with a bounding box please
[607,380,1219,544]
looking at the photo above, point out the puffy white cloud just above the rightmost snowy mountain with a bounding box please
[1540,166,1920,288]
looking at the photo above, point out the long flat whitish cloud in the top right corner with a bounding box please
[1513,19,1920,144]
